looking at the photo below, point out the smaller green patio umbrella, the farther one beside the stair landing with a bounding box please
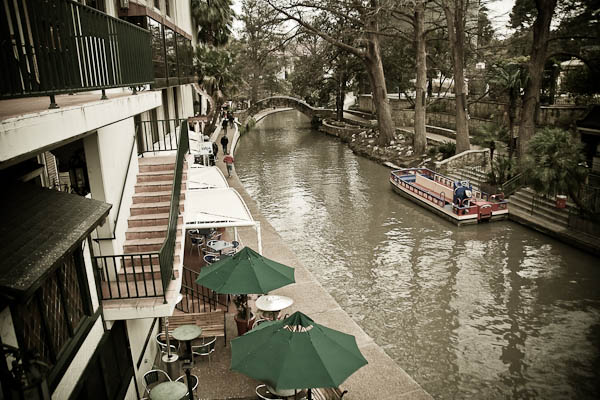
[196,247,296,294]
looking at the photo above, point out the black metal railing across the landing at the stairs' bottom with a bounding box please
[93,252,165,300]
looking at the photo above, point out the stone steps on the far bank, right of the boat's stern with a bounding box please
[508,188,569,231]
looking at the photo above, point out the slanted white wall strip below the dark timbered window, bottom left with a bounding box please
[52,318,104,400]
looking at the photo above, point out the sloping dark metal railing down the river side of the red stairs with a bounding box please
[159,120,189,301]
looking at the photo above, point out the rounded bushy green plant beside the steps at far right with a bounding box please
[523,128,587,196]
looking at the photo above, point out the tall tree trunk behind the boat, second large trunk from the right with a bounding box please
[443,0,471,154]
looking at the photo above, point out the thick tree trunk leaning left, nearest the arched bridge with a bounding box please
[365,28,396,146]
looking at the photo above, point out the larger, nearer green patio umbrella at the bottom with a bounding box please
[231,311,367,390]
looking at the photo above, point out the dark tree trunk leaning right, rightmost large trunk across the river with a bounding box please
[518,0,557,159]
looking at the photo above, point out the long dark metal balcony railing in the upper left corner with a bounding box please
[0,0,154,98]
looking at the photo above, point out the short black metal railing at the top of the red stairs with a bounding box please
[136,118,187,156]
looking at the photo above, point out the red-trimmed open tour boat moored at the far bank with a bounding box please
[390,168,508,226]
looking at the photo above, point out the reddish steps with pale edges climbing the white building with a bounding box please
[102,157,187,297]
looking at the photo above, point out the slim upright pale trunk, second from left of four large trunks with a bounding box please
[413,1,427,154]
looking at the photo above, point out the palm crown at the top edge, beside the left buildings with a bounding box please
[191,0,234,46]
